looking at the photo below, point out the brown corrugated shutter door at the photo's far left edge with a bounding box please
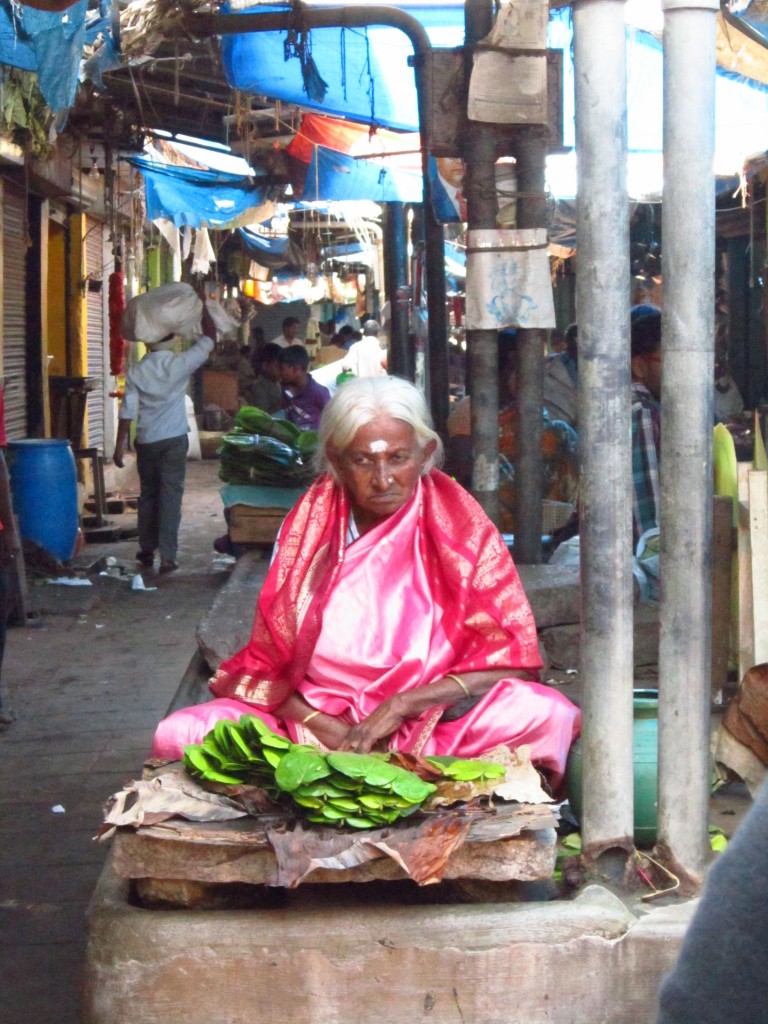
[3,182,27,440]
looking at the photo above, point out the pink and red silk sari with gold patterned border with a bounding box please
[153,471,580,785]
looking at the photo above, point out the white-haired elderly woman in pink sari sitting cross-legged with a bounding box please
[154,377,580,787]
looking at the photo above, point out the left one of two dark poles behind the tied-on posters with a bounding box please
[464,0,500,526]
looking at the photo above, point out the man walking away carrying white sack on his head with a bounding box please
[114,284,216,572]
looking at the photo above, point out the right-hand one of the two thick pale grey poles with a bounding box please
[658,0,720,884]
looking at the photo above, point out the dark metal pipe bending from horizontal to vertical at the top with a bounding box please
[183,3,449,421]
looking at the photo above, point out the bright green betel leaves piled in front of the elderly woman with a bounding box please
[183,715,504,828]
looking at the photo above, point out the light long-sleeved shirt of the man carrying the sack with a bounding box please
[119,337,213,444]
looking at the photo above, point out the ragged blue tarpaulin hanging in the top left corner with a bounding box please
[0,0,88,111]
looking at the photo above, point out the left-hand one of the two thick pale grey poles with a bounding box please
[573,0,633,869]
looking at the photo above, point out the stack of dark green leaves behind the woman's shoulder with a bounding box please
[218,406,317,487]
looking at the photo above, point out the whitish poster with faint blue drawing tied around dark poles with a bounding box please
[466,227,555,331]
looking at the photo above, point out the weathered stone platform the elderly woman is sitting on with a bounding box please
[85,554,695,1024]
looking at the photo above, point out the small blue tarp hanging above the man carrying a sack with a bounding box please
[130,157,266,227]
